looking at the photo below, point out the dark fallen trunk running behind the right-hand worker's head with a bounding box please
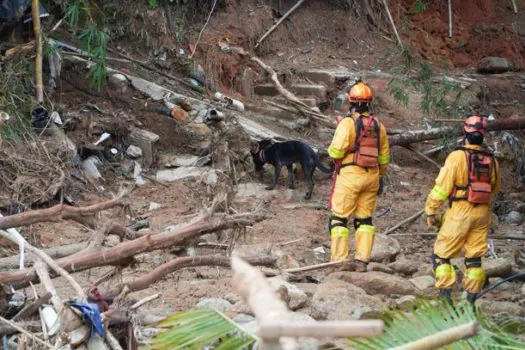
[388,117,525,146]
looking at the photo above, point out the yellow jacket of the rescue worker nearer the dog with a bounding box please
[328,112,390,176]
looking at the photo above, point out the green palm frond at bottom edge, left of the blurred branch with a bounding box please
[143,309,257,350]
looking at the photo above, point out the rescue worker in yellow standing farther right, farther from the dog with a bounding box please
[425,115,501,303]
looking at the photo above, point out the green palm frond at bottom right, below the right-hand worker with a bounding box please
[350,299,525,350]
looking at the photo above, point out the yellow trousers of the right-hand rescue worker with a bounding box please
[434,200,490,293]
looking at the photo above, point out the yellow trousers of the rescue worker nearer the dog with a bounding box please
[330,165,379,263]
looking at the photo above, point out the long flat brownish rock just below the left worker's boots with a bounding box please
[327,271,419,295]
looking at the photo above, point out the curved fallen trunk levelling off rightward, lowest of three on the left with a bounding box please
[102,256,276,296]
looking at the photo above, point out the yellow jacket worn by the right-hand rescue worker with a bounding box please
[425,145,501,215]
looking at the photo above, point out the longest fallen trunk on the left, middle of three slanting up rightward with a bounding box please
[0,210,264,288]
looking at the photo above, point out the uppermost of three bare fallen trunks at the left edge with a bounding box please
[0,195,126,230]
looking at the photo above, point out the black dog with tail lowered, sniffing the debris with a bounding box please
[250,140,334,199]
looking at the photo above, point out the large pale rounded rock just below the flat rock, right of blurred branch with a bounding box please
[310,279,382,320]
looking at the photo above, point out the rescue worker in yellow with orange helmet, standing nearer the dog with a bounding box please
[328,80,390,272]
